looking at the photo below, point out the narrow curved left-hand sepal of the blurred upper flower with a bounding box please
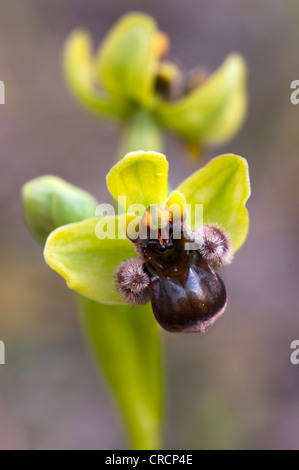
[63,29,128,119]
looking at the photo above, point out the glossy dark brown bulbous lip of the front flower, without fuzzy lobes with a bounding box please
[141,227,227,332]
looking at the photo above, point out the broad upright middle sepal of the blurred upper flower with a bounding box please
[97,13,157,104]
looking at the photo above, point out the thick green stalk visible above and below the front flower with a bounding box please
[79,111,164,450]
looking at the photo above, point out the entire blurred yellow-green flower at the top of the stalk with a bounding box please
[64,13,247,156]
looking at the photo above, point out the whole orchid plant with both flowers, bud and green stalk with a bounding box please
[22,13,250,449]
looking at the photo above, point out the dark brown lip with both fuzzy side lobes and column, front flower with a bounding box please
[115,208,232,332]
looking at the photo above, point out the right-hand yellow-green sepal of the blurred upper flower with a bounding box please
[157,54,247,145]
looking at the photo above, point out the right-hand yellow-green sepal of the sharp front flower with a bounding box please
[177,155,250,251]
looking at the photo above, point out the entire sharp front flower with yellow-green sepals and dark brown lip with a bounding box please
[44,151,250,332]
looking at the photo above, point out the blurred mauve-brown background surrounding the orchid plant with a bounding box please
[0,0,299,449]
